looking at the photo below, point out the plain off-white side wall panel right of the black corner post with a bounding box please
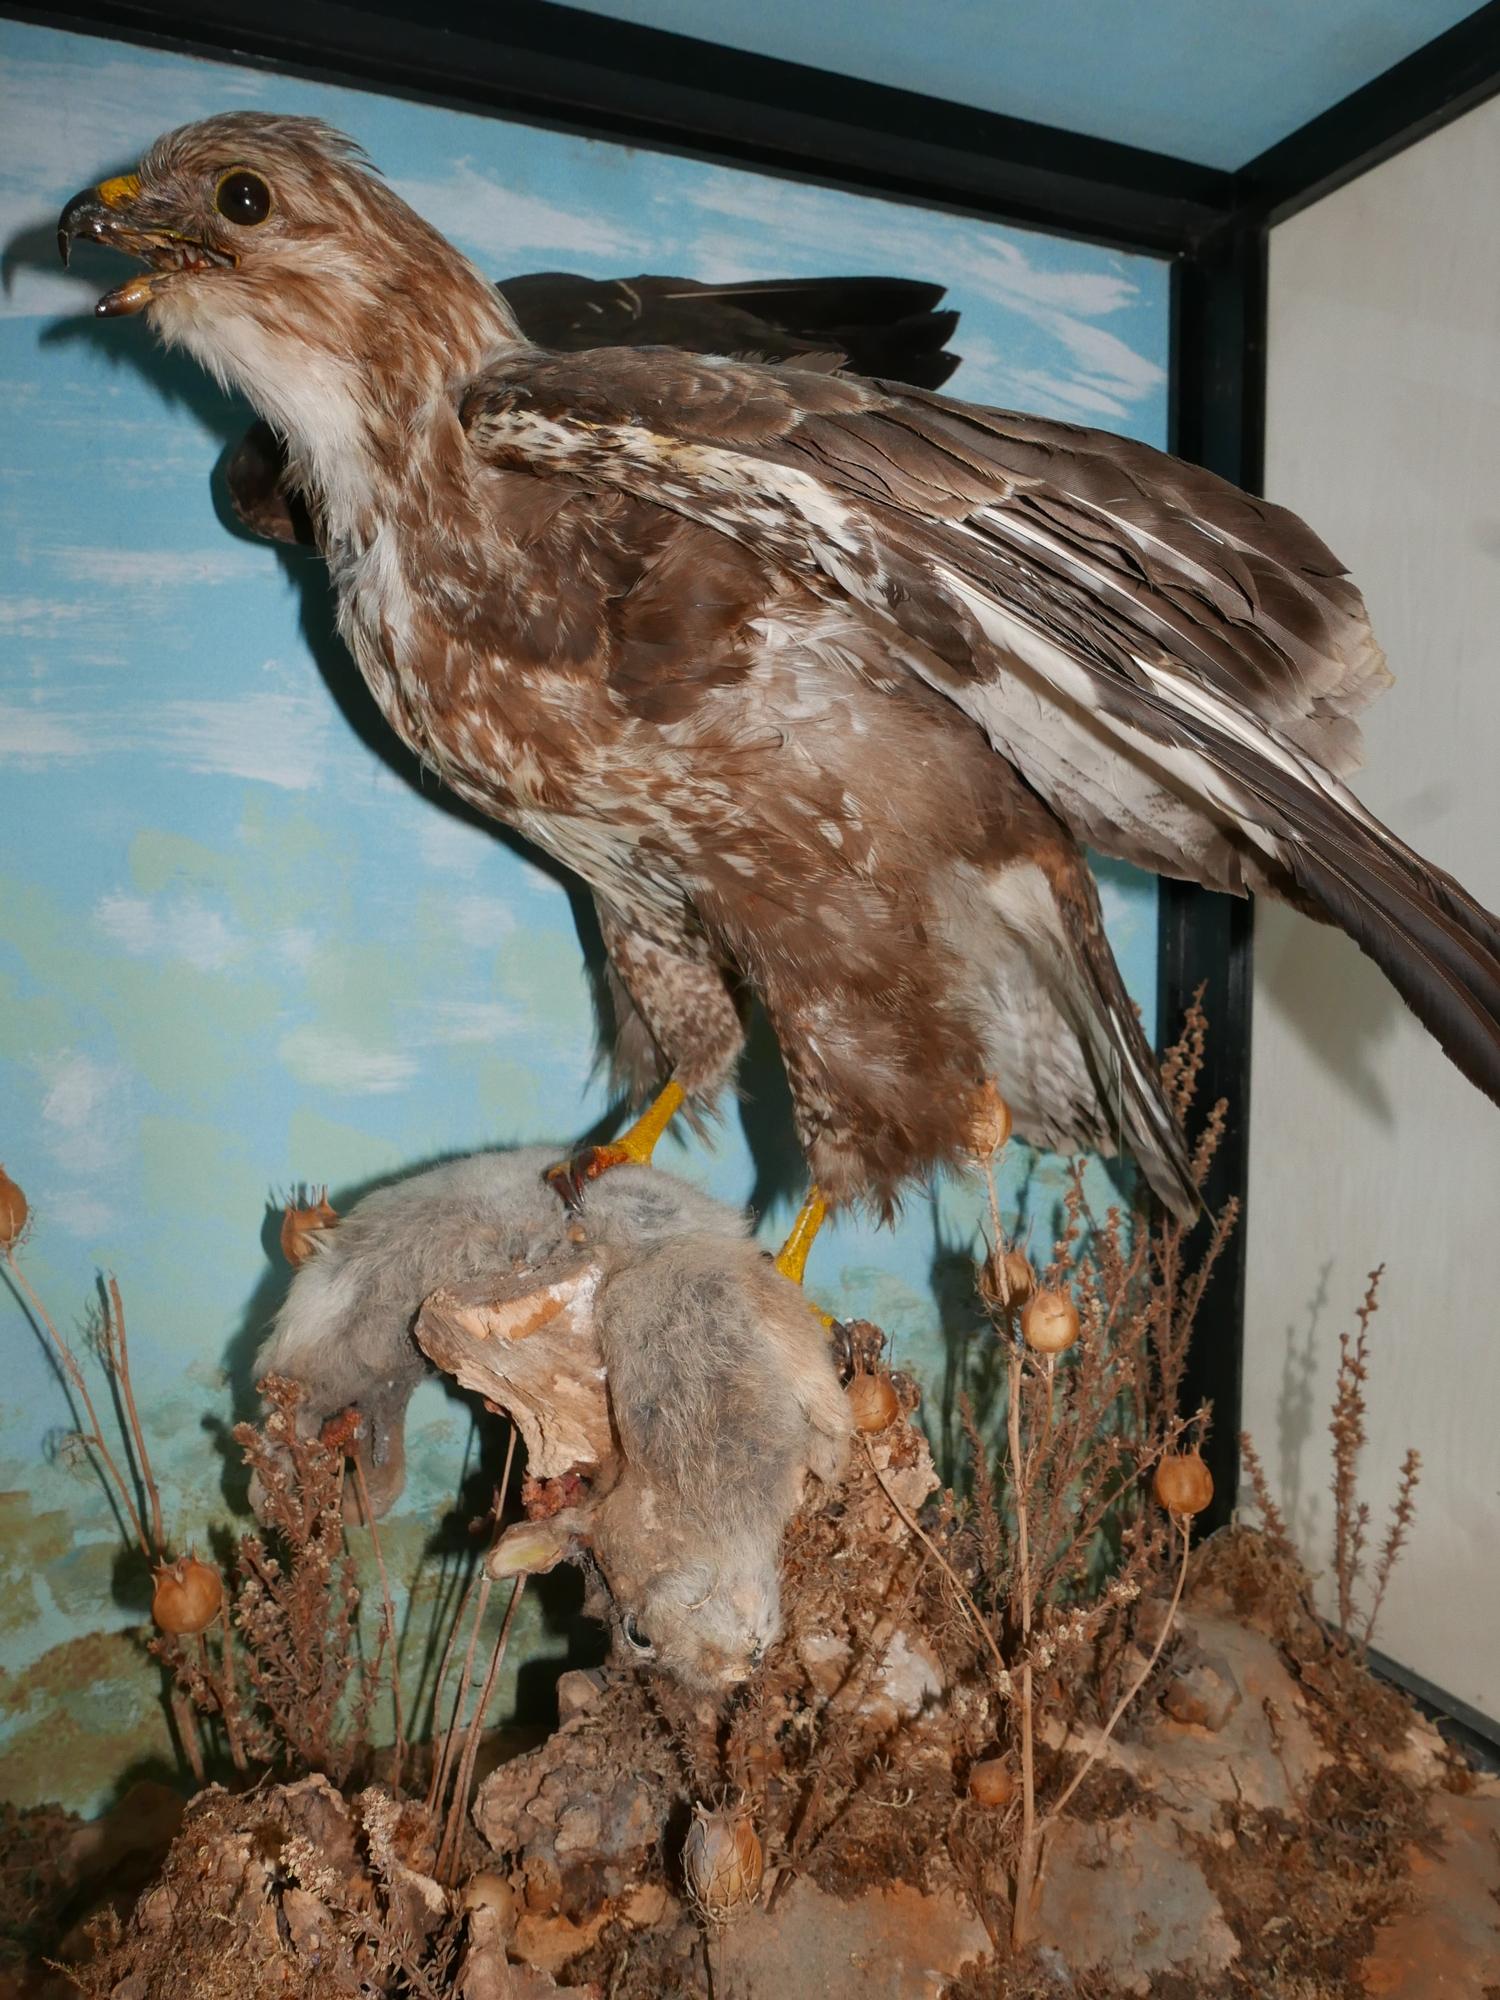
[1246,90,1500,1718]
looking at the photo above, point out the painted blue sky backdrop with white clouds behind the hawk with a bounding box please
[0,11,1168,1816]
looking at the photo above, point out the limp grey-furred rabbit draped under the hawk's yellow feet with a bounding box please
[256,1148,848,1688]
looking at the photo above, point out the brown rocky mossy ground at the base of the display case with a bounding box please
[0,1424,1500,2000]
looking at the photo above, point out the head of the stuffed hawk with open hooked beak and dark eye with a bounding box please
[58,112,516,508]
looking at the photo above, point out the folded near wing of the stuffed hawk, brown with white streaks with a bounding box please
[468,356,1500,1128]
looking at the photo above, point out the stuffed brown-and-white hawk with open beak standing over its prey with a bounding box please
[60,112,1500,1214]
